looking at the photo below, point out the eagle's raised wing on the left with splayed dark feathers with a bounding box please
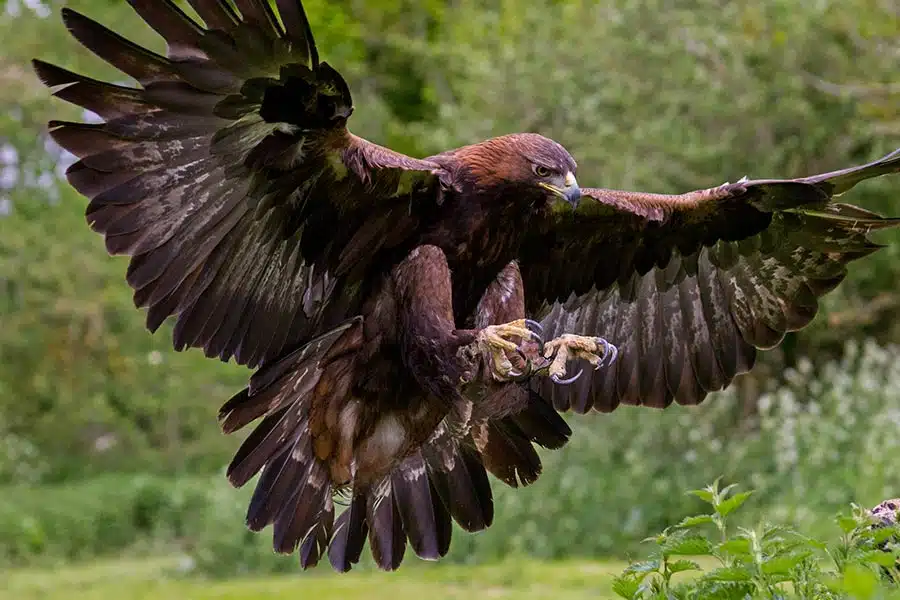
[34,0,440,366]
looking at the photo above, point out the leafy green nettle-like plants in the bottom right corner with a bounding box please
[613,480,900,600]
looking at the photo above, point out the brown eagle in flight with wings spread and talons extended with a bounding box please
[34,0,900,571]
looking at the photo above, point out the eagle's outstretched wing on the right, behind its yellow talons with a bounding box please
[520,150,900,412]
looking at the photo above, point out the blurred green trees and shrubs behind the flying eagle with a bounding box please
[0,0,900,596]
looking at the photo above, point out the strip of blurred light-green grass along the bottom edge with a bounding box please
[0,558,625,600]
